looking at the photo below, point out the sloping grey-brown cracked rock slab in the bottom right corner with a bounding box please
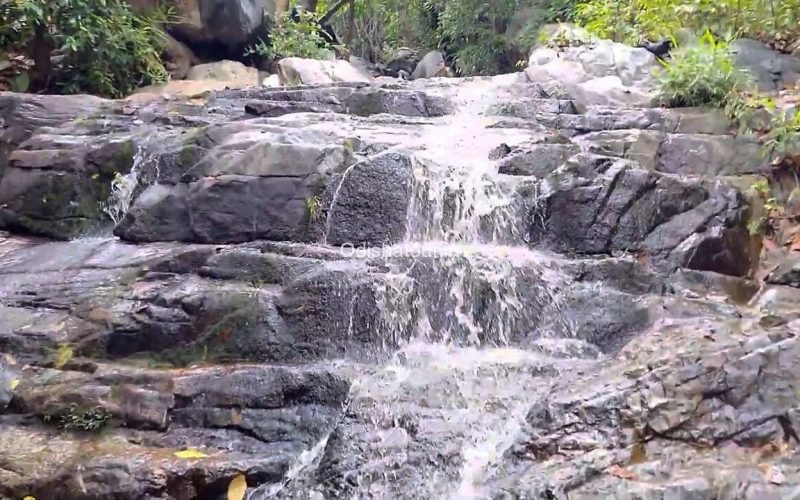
[492,318,798,498]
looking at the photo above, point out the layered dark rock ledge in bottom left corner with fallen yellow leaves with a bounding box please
[0,362,349,499]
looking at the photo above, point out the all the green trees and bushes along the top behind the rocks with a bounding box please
[0,0,800,106]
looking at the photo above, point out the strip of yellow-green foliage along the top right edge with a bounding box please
[575,0,800,44]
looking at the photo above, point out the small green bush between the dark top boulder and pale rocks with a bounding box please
[245,6,334,60]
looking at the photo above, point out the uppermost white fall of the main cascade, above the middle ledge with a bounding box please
[406,79,531,244]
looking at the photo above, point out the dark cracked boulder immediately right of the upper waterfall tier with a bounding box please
[530,154,758,276]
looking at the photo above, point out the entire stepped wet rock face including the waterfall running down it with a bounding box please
[0,60,800,499]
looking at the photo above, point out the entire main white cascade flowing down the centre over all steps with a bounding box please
[286,79,571,499]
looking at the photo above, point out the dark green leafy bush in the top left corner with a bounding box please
[0,0,167,97]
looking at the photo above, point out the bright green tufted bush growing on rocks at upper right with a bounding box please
[656,32,751,107]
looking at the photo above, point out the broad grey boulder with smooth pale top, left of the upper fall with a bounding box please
[116,124,354,243]
